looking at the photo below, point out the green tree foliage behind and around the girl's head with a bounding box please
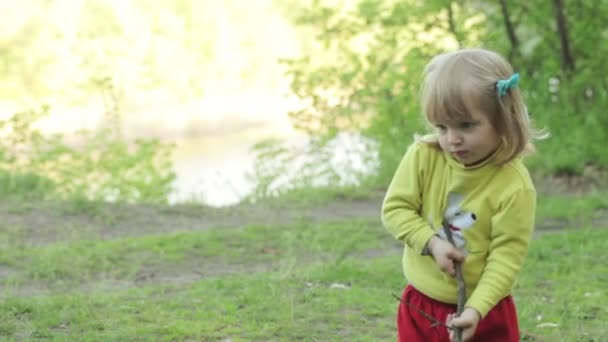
[253,0,608,198]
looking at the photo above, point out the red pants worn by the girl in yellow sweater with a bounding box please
[397,285,519,342]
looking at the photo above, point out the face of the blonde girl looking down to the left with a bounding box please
[434,112,501,165]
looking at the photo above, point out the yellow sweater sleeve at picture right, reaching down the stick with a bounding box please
[465,189,536,317]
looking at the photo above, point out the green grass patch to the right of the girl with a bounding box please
[516,227,608,341]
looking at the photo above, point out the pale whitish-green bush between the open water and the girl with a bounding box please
[247,134,377,202]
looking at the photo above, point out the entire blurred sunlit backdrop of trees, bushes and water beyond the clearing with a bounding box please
[0,0,608,206]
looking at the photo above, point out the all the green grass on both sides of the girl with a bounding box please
[0,196,608,341]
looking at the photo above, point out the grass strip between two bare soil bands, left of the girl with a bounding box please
[0,220,386,284]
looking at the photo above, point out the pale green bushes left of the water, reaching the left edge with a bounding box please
[0,108,175,203]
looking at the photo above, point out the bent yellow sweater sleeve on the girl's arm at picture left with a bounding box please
[382,143,435,253]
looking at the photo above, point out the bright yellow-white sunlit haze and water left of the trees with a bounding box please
[0,0,302,205]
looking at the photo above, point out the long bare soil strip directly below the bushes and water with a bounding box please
[0,193,382,246]
